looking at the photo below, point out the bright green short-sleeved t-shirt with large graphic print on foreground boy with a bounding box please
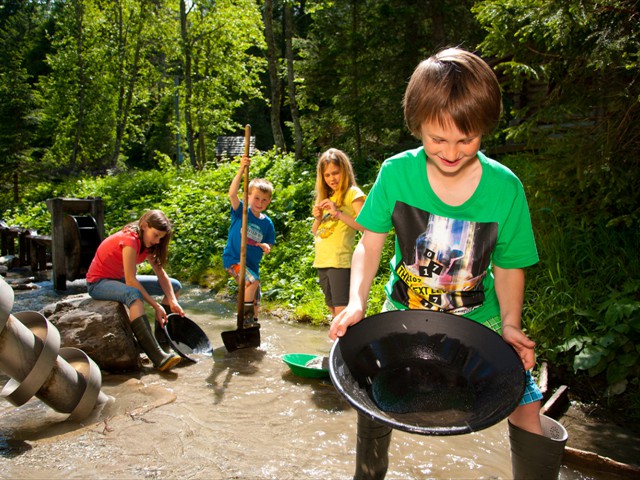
[357,147,538,322]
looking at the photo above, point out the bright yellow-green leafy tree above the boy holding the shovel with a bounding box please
[179,0,264,168]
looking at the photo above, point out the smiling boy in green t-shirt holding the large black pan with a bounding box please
[329,48,556,478]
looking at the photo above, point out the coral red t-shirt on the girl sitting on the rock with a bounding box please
[87,230,148,283]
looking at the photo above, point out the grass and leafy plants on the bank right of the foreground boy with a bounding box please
[508,157,640,412]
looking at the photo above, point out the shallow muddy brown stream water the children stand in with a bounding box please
[0,282,608,479]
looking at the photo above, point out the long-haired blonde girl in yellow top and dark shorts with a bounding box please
[311,148,366,317]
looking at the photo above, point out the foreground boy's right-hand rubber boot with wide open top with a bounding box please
[509,415,569,480]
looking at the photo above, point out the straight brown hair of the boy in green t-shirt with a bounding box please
[402,48,502,138]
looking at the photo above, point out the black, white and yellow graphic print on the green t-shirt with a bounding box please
[391,202,498,314]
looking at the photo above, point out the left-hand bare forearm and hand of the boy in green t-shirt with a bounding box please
[329,230,387,340]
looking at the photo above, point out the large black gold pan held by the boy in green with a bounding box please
[329,310,525,435]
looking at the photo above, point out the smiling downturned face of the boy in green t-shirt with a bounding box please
[420,117,482,176]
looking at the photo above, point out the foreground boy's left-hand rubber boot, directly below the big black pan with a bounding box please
[353,413,392,480]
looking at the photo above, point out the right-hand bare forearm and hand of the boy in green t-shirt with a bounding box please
[493,265,536,370]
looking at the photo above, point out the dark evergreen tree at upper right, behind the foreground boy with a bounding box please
[474,0,640,228]
